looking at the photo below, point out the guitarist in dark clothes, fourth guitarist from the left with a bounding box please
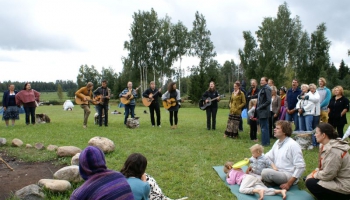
[142,81,162,127]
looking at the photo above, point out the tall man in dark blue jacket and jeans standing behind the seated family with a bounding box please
[256,77,271,146]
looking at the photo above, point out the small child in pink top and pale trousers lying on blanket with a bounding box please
[224,162,287,200]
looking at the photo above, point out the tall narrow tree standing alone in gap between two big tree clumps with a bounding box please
[189,11,216,103]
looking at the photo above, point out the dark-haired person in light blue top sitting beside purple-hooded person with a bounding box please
[120,153,151,200]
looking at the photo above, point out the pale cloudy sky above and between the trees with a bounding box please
[0,0,350,82]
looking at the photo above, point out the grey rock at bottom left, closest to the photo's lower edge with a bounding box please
[15,184,45,200]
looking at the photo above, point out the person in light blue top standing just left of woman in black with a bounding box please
[317,77,332,123]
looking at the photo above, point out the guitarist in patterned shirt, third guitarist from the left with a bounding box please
[119,81,138,125]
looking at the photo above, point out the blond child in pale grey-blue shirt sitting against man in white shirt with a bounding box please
[246,144,277,179]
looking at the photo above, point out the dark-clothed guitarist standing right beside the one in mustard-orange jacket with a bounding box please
[94,80,111,127]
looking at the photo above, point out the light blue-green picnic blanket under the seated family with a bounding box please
[213,166,314,200]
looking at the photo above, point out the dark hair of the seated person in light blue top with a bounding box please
[120,153,147,179]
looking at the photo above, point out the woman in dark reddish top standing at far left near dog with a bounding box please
[16,83,40,125]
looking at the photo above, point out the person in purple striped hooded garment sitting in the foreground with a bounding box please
[70,146,134,200]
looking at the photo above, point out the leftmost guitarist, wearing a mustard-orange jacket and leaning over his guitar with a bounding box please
[75,82,94,128]
